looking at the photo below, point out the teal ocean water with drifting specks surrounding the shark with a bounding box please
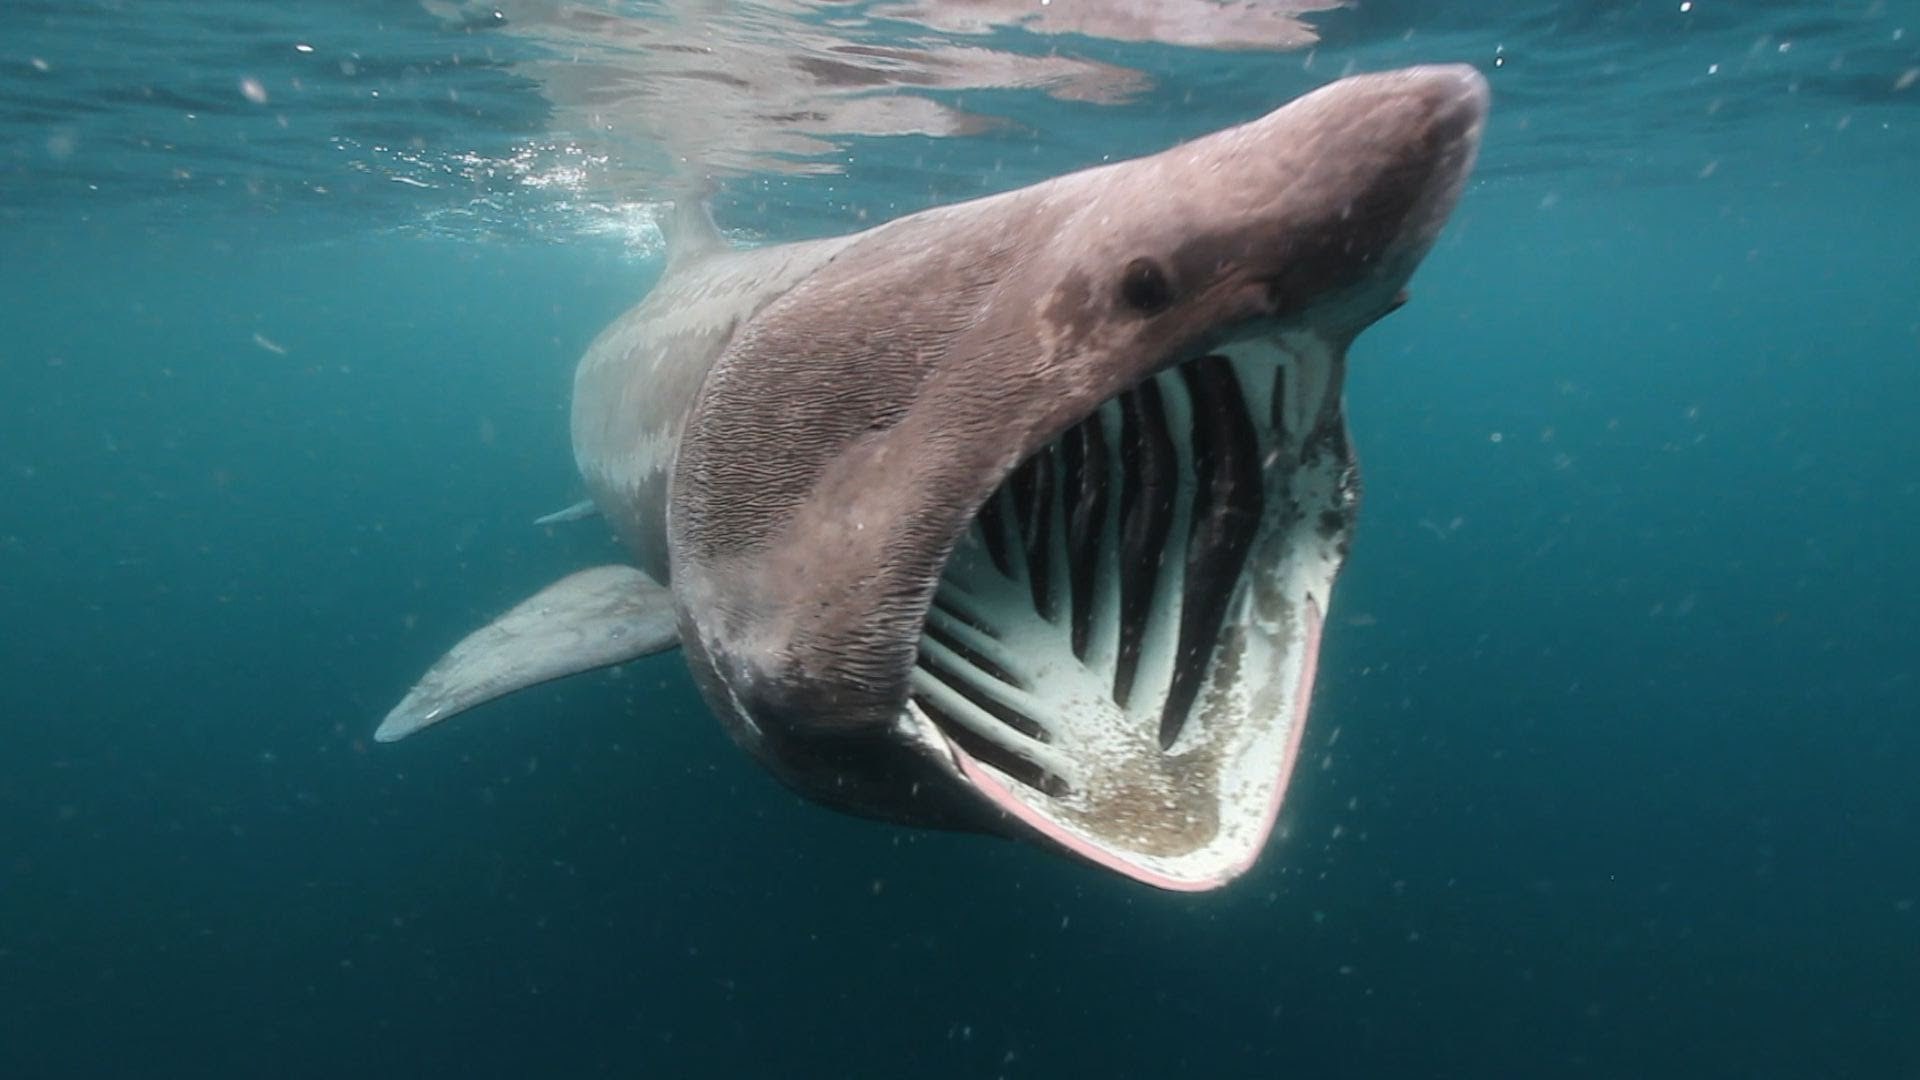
[0,0,1920,1078]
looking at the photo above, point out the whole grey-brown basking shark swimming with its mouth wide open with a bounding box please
[376,67,1488,890]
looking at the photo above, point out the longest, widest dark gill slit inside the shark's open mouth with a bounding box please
[1160,356,1263,749]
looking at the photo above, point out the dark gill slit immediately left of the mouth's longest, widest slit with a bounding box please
[1114,379,1181,709]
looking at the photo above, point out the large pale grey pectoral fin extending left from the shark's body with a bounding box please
[372,567,678,742]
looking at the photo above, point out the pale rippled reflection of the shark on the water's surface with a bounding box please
[426,0,1340,182]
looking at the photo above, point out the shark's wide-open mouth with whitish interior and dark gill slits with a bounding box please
[900,332,1357,890]
